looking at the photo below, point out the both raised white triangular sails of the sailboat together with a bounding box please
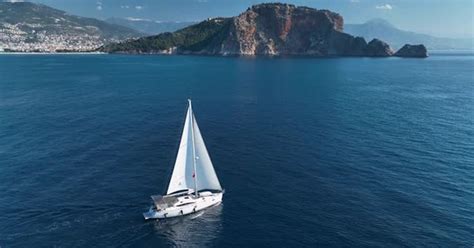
[166,100,222,194]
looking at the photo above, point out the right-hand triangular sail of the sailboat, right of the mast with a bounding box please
[193,114,222,190]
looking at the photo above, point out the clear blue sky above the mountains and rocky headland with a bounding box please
[7,0,474,38]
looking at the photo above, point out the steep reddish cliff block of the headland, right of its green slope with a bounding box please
[219,4,372,56]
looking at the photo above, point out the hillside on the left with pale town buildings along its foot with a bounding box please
[0,2,143,52]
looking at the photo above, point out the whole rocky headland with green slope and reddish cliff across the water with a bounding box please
[101,3,426,57]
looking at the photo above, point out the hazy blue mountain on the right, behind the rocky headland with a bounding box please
[344,19,474,50]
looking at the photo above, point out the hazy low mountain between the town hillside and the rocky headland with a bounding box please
[105,17,196,35]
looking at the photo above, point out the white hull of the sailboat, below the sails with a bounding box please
[143,192,223,220]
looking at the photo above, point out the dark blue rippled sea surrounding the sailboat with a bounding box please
[0,54,474,248]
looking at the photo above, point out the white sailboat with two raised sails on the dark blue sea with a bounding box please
[143,100,225,220]
